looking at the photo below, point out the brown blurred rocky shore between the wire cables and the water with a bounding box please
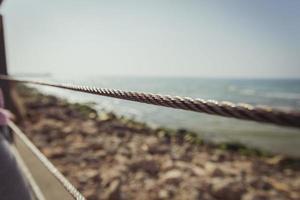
[18,85,300,200]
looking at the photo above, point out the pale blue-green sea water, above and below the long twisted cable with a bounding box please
[30,76,300,156]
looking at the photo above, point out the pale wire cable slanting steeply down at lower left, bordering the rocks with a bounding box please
[8,121,85,200]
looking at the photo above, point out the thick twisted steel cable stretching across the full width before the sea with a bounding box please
[0,75,300,127]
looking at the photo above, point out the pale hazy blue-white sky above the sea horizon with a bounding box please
[1,0,300,77]
